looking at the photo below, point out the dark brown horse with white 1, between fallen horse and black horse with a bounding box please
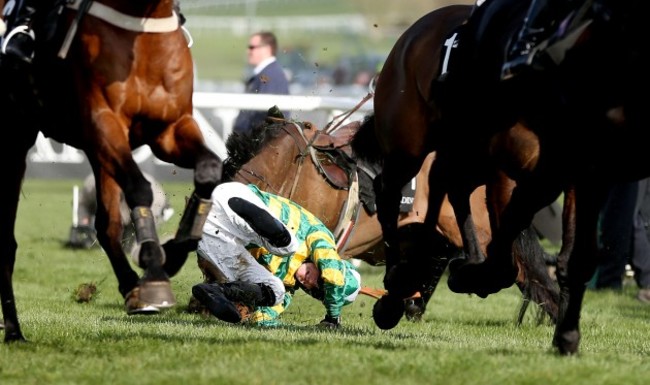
[352,5,558,328]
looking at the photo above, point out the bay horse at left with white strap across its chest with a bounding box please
[0,0,222,342]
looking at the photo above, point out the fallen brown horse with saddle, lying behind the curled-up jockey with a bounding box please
[214,110,557,323]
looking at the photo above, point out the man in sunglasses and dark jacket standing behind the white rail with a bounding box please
[233,31,289,134]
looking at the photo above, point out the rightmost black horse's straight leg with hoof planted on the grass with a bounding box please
[553,185,607,355]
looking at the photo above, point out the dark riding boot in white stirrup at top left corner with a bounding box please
[0,0,36,63]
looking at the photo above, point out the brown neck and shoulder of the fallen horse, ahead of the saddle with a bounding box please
[222,112,349,230]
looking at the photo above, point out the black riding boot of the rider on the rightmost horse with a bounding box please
[501,0,556,79]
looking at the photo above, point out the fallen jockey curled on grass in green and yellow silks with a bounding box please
[187,182,361,327]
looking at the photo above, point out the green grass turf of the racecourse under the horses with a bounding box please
[0,180,650,385]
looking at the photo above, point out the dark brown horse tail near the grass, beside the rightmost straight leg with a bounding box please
[513,226,560,324]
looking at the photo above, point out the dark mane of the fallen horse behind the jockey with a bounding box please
[222,122,284,181]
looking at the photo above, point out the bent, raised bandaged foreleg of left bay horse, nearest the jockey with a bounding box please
[149,114,222,277]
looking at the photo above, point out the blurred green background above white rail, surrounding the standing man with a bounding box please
[181,0,473,96]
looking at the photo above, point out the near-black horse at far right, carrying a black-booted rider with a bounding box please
[418,0,650,355]
